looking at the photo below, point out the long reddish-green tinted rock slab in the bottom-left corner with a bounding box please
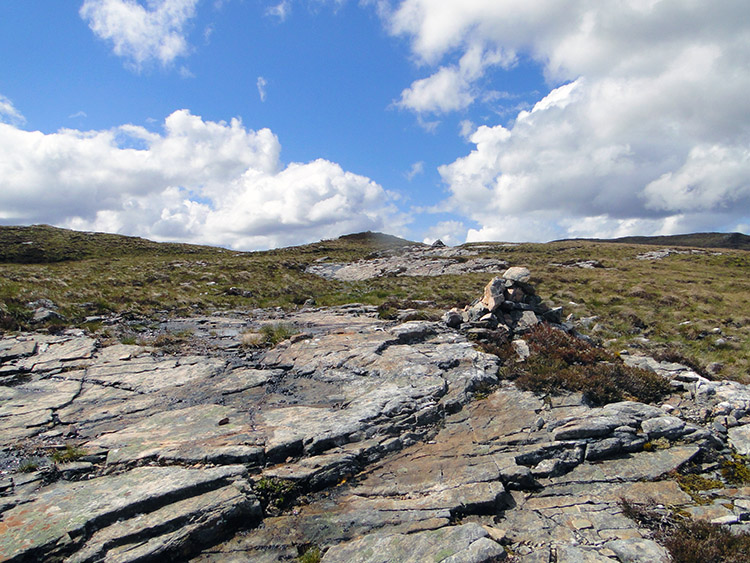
[0,466,246,560]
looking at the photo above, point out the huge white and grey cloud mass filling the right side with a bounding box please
[385,0,750,240]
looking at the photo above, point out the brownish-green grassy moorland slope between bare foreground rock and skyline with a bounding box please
[0,227,750,377]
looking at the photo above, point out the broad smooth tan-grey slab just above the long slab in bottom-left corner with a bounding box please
[83,404,262,464]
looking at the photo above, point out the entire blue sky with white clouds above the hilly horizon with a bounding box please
[0,0,750,250]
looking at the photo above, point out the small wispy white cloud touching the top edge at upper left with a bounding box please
[79,0,198,70]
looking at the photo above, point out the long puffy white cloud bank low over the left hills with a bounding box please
[0,110,405,249]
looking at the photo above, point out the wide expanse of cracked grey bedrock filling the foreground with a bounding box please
[0,274,750,563]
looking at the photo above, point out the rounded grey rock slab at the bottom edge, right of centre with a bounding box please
[322,524,507,563]
